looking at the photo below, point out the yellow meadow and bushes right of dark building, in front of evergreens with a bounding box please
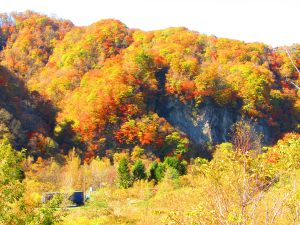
[61,134,300,225]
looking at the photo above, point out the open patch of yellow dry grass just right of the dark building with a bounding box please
[62,175,203,225]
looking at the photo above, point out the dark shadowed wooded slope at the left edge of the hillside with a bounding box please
[0,66,56,148]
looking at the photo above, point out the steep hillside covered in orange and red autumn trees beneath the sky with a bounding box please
[1,11,300,159]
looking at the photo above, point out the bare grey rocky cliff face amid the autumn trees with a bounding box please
[157,96,272,148]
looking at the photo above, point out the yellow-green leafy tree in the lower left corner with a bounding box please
[0,137,63,225]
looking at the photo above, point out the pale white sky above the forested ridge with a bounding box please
[0,0,300,47]
